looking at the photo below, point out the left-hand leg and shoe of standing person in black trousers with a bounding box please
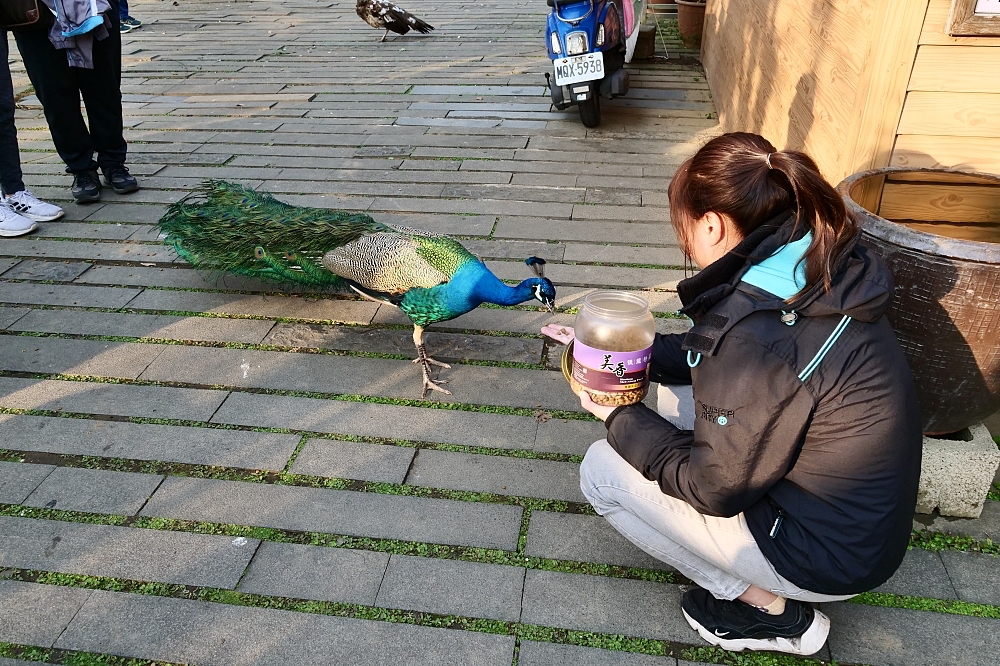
[14,30,101,202]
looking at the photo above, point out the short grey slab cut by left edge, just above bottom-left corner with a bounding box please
[0,580,92,647]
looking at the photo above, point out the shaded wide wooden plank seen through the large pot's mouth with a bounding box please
[879,183,1000,223]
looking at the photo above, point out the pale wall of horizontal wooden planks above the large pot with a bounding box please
[891,0,1000,174]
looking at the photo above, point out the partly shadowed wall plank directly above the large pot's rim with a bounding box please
[890,134,1000,174]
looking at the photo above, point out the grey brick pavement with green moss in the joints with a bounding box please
[0,0,1000,666]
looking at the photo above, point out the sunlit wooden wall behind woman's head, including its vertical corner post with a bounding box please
[702,0,928,189]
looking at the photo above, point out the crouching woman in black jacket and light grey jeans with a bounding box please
[543,133,921,655]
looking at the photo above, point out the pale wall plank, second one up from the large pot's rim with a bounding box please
[898,91,1000,137]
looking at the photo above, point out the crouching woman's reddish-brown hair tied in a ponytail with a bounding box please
[668,132,860,299]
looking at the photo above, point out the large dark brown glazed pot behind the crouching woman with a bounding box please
[837,167,1000,434]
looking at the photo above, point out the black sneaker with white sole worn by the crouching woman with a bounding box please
[681,588,830,655]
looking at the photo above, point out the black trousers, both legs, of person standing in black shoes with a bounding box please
[14,5,127,173]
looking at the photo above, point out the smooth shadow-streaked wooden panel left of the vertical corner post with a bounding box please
[702,0,880,182]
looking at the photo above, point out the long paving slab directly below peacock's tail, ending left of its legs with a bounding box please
[129,290,379,324]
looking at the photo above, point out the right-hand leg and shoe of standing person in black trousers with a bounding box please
[75,0,139,194]
